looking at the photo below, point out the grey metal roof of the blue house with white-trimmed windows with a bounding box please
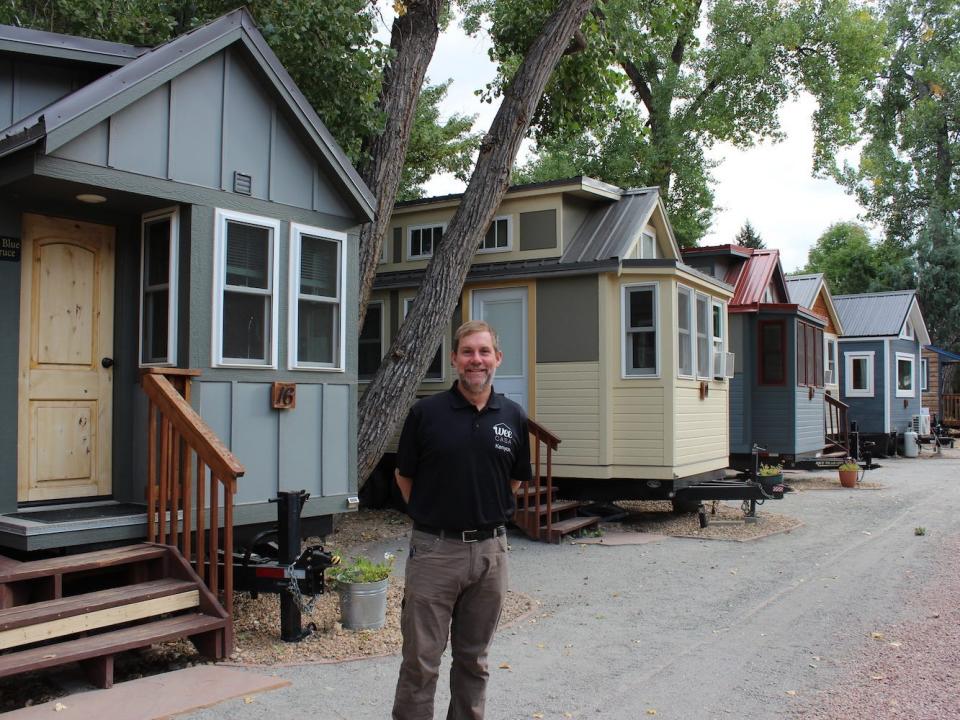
[833,290,930,345]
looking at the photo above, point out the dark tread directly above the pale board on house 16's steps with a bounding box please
[0,578,197,636]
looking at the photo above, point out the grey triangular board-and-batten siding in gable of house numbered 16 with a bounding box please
[52,48,353,217]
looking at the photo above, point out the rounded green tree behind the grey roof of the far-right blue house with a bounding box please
[803,222,916,295]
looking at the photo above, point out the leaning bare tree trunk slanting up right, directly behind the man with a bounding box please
[357,0,594,482]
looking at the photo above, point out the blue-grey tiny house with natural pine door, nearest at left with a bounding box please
[0,10,373,552]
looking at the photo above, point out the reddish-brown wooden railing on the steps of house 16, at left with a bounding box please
[140,368,245,617]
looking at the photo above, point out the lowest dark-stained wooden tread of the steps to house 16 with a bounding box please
[0,613,228,677]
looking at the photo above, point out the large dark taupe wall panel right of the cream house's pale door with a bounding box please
[537,275,600,363]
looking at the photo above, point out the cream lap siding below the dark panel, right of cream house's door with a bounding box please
[534,362,600,465]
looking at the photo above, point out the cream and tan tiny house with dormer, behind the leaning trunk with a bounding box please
[370,177,732,498]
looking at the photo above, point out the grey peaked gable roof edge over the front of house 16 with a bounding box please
[0,8,376,219]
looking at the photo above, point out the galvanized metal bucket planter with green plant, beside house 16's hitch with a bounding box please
[326,553,396,630]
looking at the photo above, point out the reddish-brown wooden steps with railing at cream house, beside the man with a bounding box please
[513,418,600,543]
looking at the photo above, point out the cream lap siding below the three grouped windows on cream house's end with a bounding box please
[673,381,730,475]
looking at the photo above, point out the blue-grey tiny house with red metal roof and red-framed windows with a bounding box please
[684,245,828,467]
